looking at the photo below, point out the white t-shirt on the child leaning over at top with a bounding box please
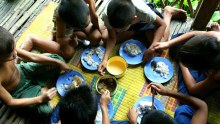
[101,0,156,29]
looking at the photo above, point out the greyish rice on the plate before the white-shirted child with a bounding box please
[124,43,141,56]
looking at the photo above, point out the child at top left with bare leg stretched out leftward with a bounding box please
[22,0,107,60]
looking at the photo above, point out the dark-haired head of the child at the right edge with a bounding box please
[177,35,220,71]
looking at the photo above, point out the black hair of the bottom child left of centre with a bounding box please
[59,85,98,124]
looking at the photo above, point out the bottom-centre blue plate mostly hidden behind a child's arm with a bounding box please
[96,95,114,124]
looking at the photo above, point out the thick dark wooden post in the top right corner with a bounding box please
[192,0,220,30]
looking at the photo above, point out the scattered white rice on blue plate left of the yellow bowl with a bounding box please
[83,47,104,67]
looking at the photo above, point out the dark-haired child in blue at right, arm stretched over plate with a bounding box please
[154,31,220,95]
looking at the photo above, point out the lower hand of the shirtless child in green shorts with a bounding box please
[41,87,57,102]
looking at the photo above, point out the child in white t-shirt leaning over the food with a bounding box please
[98,0,187,74]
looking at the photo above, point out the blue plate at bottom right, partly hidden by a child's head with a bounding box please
[134,96,165,124]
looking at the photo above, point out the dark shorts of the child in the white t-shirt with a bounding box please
[128,3,163,31]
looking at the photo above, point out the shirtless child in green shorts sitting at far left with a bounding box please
[0,27,70,116]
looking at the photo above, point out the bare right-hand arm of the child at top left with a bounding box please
[87,0,100,31]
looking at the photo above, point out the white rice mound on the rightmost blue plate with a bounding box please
[154,62,169,78]
